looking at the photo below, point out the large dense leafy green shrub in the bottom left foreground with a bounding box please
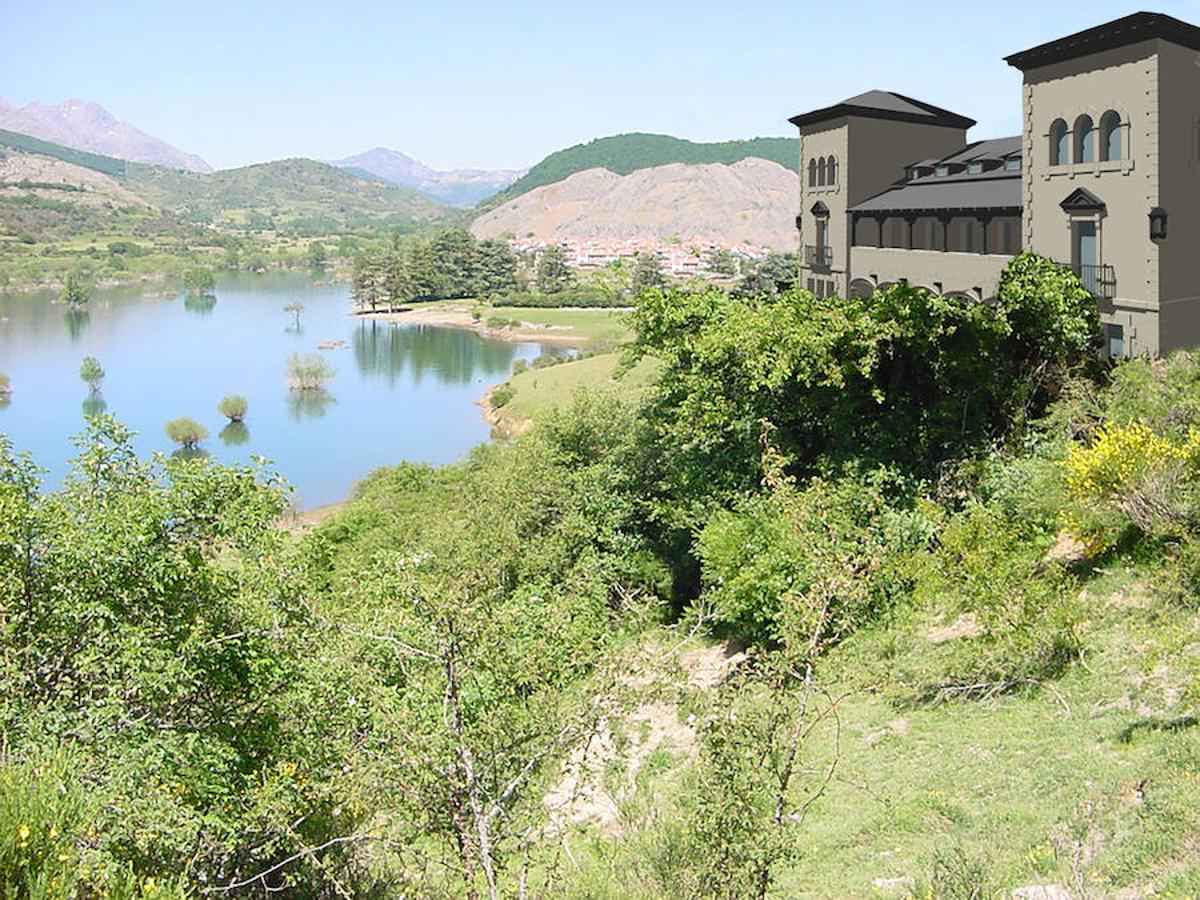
[0,418,356,895]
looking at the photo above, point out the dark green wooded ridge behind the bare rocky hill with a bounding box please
[480,132,800,211]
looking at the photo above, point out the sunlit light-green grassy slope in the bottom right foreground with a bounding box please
[561,566,1200,898]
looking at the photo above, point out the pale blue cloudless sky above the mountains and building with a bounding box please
[0,0,1200,168]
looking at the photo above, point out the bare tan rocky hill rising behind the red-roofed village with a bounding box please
[472,158,799,250]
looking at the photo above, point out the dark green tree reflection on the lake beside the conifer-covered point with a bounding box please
[353,319,516,384]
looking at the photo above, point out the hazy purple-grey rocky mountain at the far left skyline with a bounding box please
[0,98,212,172]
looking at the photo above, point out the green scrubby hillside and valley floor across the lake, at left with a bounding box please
[0,131,464,287]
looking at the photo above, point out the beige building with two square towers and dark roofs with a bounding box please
[791,12,1200,356]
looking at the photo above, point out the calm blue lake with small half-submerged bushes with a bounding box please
[0,274,541,509]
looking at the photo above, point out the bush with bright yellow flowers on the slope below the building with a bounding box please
[1062,420,1200,551]
